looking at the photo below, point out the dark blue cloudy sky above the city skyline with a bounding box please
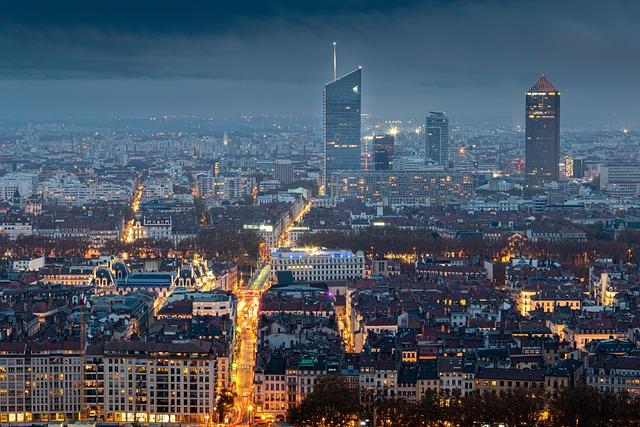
[0,0,640,125]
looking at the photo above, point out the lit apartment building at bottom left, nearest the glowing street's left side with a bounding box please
[103,340,216,423]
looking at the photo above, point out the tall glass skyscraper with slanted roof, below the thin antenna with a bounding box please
[323,68,362,182]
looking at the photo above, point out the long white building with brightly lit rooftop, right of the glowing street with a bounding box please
[271,248,365,282]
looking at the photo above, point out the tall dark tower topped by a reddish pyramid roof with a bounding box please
[525,74,560,194]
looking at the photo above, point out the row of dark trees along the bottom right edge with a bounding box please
[287,376,640,427]
